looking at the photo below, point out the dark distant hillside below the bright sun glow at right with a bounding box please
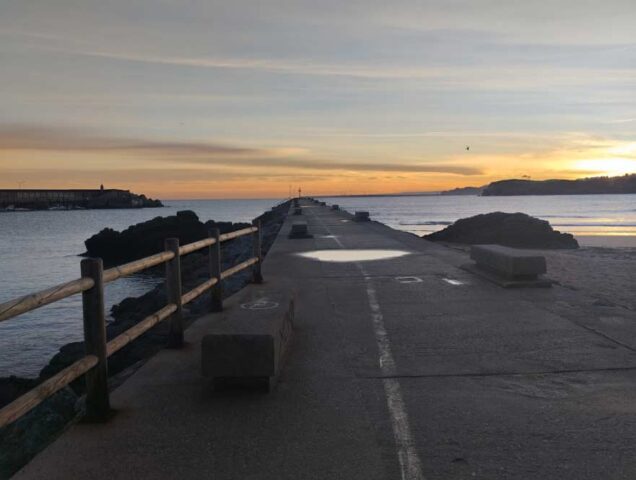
[482,174,636,196]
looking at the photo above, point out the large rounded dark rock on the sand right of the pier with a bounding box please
[423,212,579,248]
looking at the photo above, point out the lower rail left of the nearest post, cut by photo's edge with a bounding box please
[0,355,97,428]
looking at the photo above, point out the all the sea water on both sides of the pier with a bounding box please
[0,195,636,376]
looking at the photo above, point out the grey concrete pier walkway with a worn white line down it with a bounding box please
[15,204,636,480]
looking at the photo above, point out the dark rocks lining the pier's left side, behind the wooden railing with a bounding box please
[0,202,289,479]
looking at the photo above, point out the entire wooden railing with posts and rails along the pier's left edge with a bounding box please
[0,220,263,428]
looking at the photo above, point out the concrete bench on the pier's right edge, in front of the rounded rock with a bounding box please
[464,245,552,287]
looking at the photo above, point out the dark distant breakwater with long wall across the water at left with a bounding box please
[0,185,163,211]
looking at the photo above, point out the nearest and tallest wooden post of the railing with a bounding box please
[80,258,110,422]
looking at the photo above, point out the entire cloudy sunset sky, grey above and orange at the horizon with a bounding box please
[0,0,636,199]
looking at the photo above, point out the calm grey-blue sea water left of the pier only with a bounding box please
[0,200,278,376]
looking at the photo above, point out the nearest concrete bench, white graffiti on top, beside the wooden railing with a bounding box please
[201,281,294,391]
